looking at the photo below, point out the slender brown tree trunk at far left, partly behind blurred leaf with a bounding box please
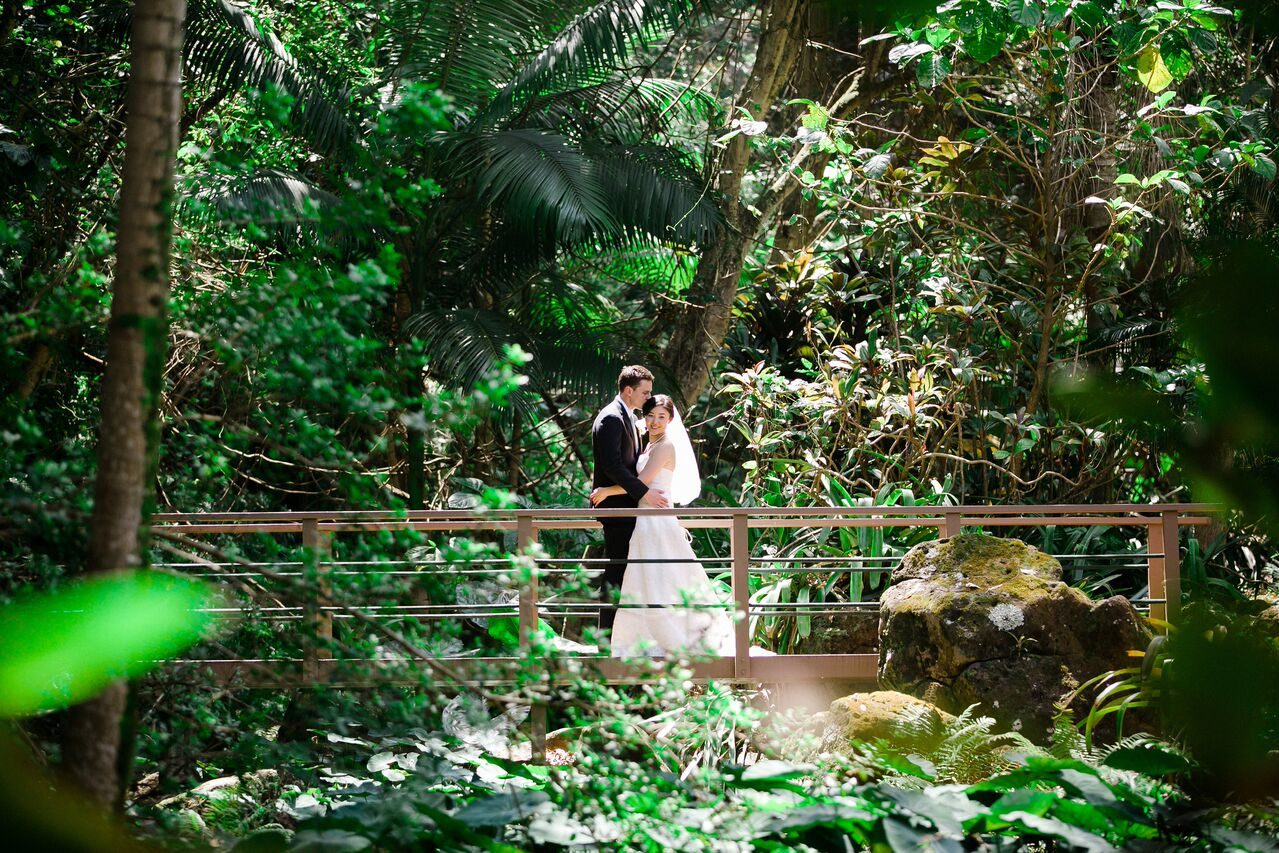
[63,0,187,808]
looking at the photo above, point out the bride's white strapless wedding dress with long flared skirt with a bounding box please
[613,450,735,657]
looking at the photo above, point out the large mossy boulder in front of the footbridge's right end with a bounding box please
[879,535,1151,737]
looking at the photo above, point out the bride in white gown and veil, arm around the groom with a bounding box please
[591,394,734,657]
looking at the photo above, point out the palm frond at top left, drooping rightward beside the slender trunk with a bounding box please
[184,0,354,151]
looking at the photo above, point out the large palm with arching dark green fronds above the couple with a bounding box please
[176,0,720,411]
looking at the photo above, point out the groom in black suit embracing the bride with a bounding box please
[591,364,670,630]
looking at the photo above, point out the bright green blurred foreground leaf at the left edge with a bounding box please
[0,570,214,717]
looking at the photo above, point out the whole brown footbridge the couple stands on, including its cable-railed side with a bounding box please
[153,504,1218,688]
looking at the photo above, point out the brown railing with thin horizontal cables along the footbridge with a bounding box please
[153,504,1218,687]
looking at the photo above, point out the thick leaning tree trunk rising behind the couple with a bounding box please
[663,0,807,409]
